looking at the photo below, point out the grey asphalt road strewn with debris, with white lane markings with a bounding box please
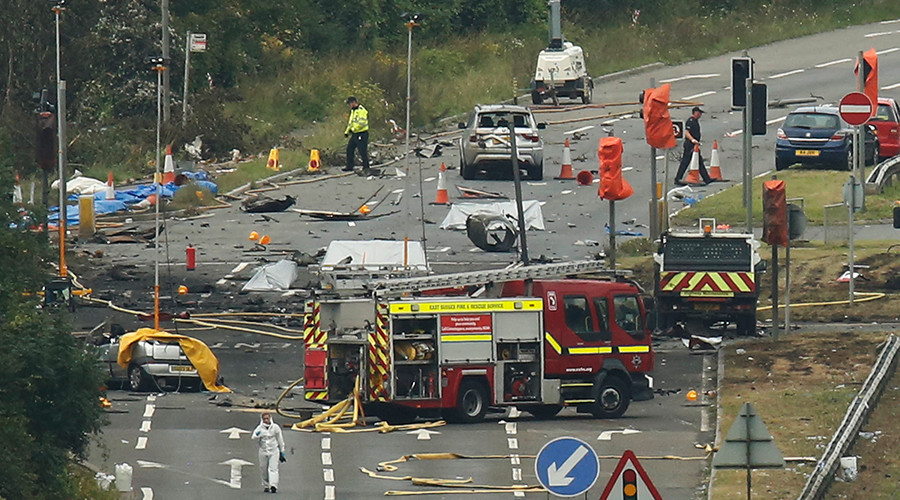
[74,22,900,499]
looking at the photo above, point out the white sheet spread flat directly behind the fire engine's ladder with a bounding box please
[321,240,428,271]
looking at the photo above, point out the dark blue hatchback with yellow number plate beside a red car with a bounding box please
[775,106,879,170]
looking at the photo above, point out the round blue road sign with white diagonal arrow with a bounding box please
[534,437,600,497]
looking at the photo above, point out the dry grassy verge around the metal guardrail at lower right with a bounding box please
[712,330,900,500]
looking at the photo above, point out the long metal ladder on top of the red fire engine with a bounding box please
[372,260,631,297]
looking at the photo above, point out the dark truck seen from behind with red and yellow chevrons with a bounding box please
[653,223,765,334]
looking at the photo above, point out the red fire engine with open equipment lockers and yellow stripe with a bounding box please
[304,261,654,422]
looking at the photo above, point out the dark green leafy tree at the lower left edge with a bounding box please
[0,158,103,500]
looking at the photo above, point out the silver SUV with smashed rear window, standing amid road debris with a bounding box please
[459,104,547,180]
